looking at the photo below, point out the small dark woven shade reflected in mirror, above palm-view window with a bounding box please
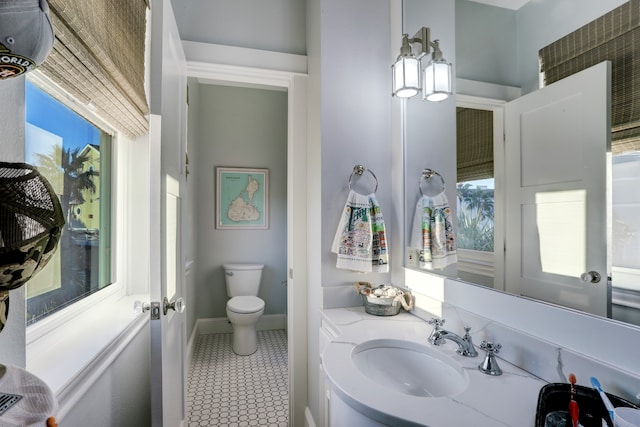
[456,107,493,182]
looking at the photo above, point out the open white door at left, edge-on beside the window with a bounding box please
[149,0,187,427]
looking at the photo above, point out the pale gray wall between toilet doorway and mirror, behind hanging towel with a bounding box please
[307,0,400,420]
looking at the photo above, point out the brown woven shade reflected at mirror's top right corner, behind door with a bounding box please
[538,0,640,154]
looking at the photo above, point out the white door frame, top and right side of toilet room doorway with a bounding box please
[183,41,308,426]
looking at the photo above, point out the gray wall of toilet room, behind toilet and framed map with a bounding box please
[189,81,287,319]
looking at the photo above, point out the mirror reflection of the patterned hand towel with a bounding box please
[410,191,458,270]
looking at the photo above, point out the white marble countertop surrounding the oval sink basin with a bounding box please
[321,307,546,427]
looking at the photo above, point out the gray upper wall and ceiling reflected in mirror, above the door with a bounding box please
[456,0,626,94]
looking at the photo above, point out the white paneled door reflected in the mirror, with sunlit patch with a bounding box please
[505,62,611,316]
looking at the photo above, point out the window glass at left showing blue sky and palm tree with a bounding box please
[25,81,112,325]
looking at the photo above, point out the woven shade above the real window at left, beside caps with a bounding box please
[39,0,149,137]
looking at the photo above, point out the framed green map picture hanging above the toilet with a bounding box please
[216,166,269,229]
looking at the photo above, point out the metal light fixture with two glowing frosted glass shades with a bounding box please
[391,27,452,102]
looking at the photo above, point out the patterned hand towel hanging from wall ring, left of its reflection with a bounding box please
[331,190,389,273]
